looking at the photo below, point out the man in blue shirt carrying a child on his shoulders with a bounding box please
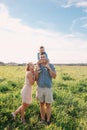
[36,54,56,125]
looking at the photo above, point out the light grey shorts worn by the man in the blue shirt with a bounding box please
[36,87,53,103]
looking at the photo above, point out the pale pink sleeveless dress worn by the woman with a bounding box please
[21,71,32,104]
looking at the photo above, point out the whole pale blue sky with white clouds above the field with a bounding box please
[0,0,87,63]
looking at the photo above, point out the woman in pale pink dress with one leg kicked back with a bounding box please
[12,62,35,124]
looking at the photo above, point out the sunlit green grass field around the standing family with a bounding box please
[0,66,87,130]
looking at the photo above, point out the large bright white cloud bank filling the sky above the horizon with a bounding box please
[0,4,87,63]
